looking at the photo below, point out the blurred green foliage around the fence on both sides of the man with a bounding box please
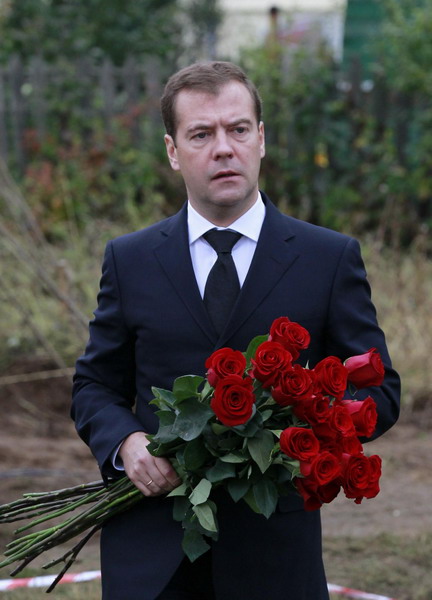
[0,0,432,247]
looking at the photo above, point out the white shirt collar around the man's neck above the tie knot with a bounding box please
[187,194,265,244]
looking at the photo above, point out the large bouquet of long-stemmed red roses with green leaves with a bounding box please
[0,317,384,589]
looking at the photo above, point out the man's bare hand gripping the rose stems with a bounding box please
[119,431,181,496]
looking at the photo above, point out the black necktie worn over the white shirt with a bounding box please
[203,229,242,334]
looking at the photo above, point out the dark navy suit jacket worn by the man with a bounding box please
[72,196,400,600]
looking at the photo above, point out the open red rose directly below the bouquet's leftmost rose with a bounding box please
[210,375,255,427]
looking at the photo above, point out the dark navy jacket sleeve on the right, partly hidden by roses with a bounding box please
[326,239,400,441]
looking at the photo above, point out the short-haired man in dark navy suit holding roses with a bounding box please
[72,62,399,600]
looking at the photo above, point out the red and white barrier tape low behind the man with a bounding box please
[0,571,395,600]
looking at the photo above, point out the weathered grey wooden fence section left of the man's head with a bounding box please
[0,57,163,171]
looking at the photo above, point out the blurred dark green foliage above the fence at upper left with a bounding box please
[0,0,181,64]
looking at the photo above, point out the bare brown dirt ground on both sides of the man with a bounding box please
[0,363,432,544]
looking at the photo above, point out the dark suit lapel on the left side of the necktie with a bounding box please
[155,205,217,345]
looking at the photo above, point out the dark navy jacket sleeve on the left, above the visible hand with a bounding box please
[71,242,143,477]
